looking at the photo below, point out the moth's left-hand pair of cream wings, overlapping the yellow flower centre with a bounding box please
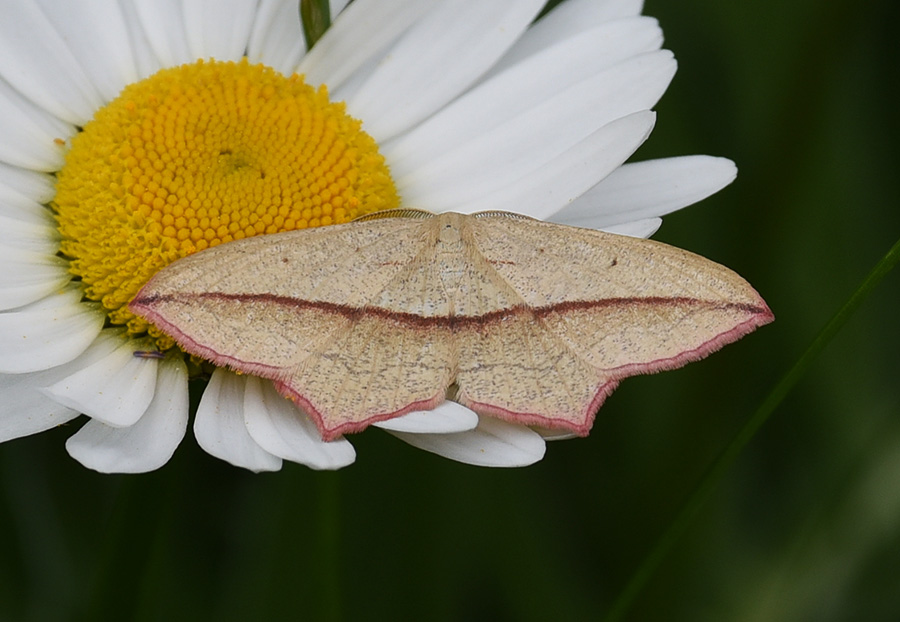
[130,212,464,439]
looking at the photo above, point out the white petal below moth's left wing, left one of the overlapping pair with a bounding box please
[194,367,281,473]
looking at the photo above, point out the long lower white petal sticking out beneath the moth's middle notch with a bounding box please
[391,417,546,467]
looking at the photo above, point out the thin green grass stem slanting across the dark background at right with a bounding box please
[605,235,900,622]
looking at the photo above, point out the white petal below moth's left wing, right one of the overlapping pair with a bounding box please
[244,376,356,470]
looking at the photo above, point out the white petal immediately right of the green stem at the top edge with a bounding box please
[297,0,436,93]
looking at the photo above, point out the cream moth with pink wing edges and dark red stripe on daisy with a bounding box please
[129,209,774,440]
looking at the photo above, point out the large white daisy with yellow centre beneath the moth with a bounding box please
[0,0,735,472]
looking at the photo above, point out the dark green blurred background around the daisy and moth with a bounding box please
[0,0,900,621]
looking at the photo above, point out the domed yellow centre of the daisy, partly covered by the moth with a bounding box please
[53,59,399,349]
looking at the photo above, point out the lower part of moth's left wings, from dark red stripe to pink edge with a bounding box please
[139,294,453,440]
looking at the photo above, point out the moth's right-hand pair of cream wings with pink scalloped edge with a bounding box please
[457,214,773,434]
